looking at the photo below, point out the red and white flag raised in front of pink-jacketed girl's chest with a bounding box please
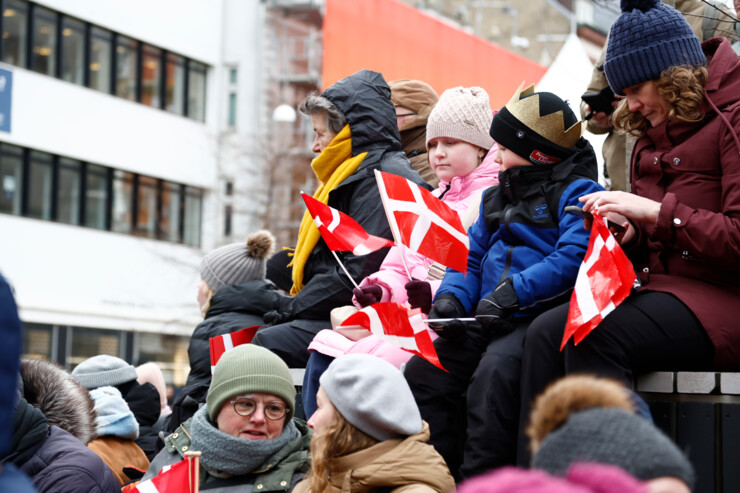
[375,170,470,273]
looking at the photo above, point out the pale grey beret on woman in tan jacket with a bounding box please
[319,354,422,441]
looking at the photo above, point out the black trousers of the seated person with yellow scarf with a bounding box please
[252,320,331,368]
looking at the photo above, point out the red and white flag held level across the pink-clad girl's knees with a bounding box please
[337,303,447,371]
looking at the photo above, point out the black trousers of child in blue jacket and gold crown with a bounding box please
[404,320,529,479]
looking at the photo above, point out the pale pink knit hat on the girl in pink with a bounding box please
[426,86,493,149]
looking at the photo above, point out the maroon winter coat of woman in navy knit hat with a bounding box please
[631,38,740,368]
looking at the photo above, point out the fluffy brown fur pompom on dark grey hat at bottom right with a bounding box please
[526,375,635,455]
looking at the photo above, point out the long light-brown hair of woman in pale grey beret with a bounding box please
[306,409,378,492]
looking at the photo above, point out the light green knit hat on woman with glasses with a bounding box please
[206,344,295,422]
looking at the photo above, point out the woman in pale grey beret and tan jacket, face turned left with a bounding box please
[295,354,455,493]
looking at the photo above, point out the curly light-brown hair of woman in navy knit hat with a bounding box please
[612,65,708,138]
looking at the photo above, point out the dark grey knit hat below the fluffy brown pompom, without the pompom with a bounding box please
[532,408,694,490]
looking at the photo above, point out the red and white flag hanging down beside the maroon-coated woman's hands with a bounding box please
[560,211,637,351]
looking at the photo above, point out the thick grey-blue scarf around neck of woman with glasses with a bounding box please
[190,406,299,478]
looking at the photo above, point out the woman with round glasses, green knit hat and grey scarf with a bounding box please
[143,344,311,492]
